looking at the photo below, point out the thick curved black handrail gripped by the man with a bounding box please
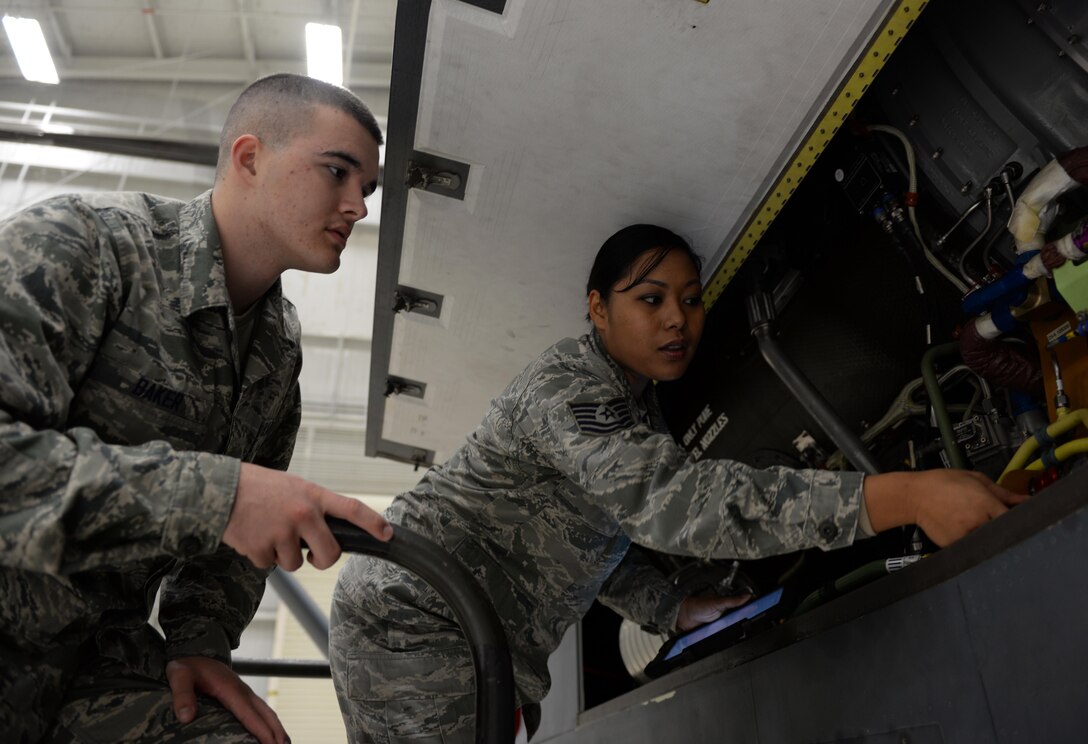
[326,517,515,744]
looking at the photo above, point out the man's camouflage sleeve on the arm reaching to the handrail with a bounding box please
[0,200,238,573]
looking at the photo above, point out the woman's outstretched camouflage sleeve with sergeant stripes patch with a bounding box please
[519,371,863,559]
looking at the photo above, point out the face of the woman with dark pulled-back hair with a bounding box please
[589,249,704,387]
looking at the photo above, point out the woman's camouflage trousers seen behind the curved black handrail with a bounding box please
[329,556,474,744]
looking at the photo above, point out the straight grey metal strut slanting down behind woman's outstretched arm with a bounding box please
[749,293,880,475]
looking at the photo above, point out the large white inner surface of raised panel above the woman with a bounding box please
[382,0,889,460]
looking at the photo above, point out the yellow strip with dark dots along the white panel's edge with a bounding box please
[703,0,928,310]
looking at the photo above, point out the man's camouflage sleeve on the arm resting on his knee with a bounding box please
[159,374,302,662]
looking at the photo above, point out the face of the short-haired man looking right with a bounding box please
[257,106,378,274]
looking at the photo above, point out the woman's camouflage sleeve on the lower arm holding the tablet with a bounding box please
[597,545,684,634]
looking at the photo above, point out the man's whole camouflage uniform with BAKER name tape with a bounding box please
[0,193,301,742]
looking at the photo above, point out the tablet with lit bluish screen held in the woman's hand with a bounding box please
[646,586,783,677]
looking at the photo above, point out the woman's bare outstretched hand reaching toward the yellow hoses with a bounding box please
[864,470,1027,547]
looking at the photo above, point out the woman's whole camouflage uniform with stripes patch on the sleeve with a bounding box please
[331,334,862,743]
